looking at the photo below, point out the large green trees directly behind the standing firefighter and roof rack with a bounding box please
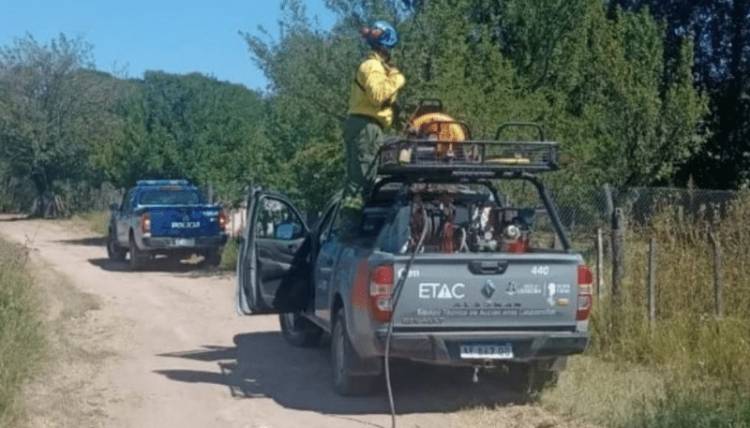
[245,0,707,214]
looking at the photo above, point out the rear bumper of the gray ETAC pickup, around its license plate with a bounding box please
[376,331,589,365]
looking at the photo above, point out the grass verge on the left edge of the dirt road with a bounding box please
[0,240,45,426]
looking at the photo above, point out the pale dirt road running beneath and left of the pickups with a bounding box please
[0,219,584,428]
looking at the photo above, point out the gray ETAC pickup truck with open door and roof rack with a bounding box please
[236,125,592,395]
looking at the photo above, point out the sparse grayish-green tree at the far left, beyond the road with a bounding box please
[0,35,122,216]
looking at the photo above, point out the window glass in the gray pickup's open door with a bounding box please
[255,197,304,241]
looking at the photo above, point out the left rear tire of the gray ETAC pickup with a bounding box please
[331,309,379,396]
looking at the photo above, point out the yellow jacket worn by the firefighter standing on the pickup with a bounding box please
[349,52,406,128]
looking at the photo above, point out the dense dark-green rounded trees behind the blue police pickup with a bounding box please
[96,72,277,203]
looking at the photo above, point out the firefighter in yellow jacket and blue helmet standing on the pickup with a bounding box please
[344,21,406,209]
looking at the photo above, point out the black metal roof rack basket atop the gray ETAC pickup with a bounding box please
[376,122,559,179]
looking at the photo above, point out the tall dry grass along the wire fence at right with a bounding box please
[542,194,750,427]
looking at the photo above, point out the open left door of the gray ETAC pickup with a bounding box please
[236,188,309,315]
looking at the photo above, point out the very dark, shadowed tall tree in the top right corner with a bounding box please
[611,0,750,188]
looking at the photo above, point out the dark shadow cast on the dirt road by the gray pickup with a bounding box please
[156,332,524,415]
